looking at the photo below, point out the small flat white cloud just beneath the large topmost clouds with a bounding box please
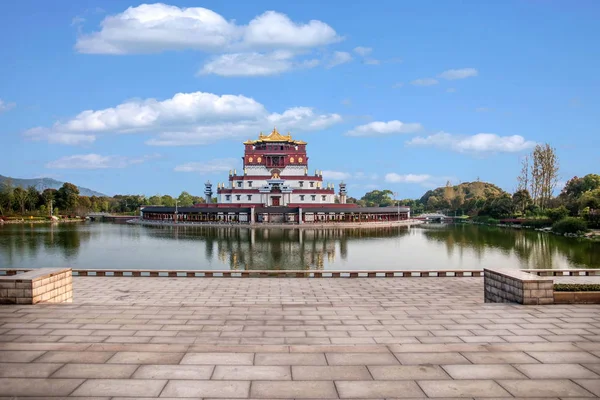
[200,51,296,76]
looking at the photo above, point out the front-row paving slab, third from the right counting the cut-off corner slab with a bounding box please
[418,380,510,397]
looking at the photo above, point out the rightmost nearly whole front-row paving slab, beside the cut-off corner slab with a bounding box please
[497,379,593,398]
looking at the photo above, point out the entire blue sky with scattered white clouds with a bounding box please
[0,0,600,198]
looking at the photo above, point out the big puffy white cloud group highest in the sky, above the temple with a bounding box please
[75,3,352,77]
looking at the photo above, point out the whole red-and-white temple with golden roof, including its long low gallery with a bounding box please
[140,129,410,224]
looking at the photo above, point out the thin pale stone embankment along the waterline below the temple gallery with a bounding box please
[127,219,423,229]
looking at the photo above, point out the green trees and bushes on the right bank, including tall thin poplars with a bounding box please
[348,144,600,231]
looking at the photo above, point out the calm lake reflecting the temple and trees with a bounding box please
[0,222,600,270]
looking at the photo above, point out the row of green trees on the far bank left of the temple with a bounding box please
[0,180,204,217]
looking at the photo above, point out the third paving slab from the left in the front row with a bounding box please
[161,380,250,399]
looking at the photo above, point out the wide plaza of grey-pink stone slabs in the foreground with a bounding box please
[0,277,600,399]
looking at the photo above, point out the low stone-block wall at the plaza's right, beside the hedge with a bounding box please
[483,268,554,305]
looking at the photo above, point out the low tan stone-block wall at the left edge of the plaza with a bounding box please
[0,268,73,304]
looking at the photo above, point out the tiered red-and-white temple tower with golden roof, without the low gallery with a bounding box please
[217,129,335,207]
